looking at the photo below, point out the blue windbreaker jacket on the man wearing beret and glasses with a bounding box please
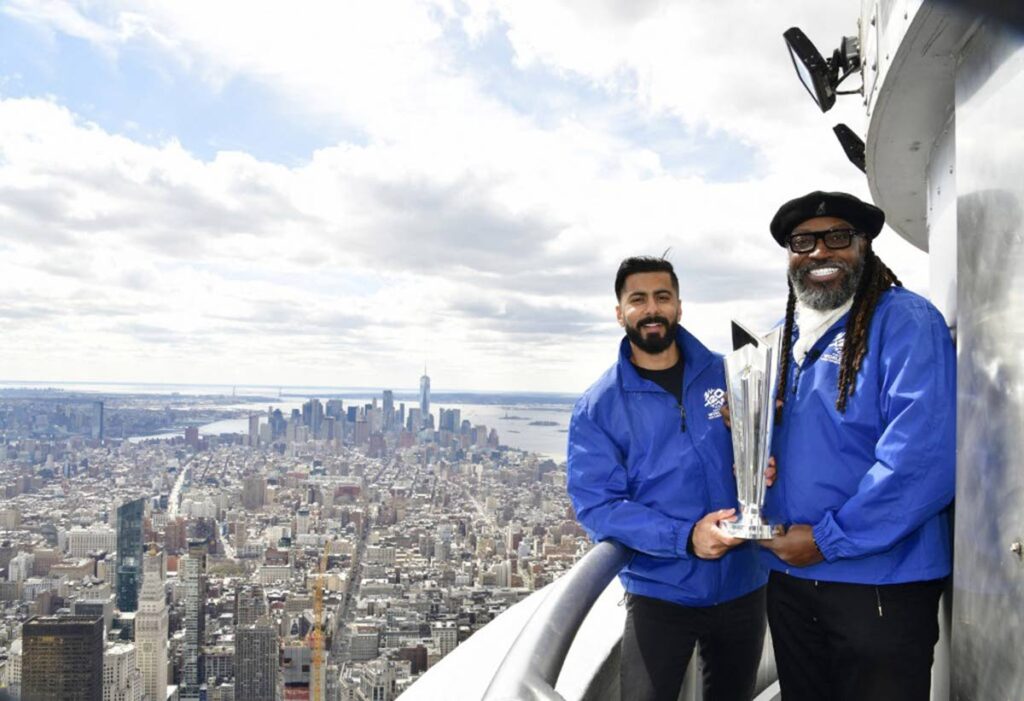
[764,288,956,584]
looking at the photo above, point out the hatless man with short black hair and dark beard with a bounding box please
[567,257,770,701]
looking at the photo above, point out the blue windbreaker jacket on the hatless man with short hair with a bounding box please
[568,328,767,606]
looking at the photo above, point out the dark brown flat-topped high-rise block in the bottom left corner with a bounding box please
[22,616,103,701]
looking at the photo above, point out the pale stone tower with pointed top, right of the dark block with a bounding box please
[135,553,167,701]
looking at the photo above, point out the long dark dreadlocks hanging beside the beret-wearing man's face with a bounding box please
[775,246,903,423]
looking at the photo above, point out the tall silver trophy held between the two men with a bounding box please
[721,321,782,540]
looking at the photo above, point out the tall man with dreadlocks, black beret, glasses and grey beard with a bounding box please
[762,192,955,701]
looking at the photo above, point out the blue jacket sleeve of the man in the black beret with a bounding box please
[814,307,956,561]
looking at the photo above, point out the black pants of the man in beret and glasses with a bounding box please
[768,572,944,701]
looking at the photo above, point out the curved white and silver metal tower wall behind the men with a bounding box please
[861,0,1024,700]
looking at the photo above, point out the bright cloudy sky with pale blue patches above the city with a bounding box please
[0,0,928,393]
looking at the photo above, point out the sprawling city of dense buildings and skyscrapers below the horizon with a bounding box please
[0,368,585,701]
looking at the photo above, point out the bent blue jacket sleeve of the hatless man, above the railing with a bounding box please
[567,401,695,558]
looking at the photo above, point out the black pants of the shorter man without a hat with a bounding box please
[621,587,765,701]
